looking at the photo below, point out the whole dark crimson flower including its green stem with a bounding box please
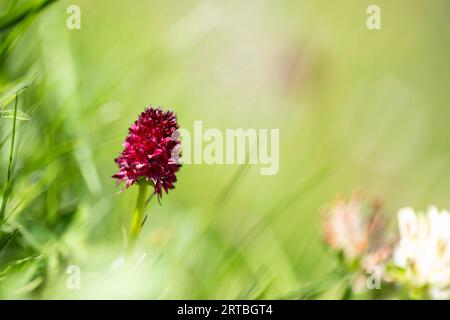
[113,106,181,262]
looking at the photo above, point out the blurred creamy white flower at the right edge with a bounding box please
[394,207,450,299]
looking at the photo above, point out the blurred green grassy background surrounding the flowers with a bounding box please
[0,0,450,299]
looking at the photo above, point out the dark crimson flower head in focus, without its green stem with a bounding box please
[113,106,181,197]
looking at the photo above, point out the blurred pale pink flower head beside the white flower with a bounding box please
[323,196,385,260]
